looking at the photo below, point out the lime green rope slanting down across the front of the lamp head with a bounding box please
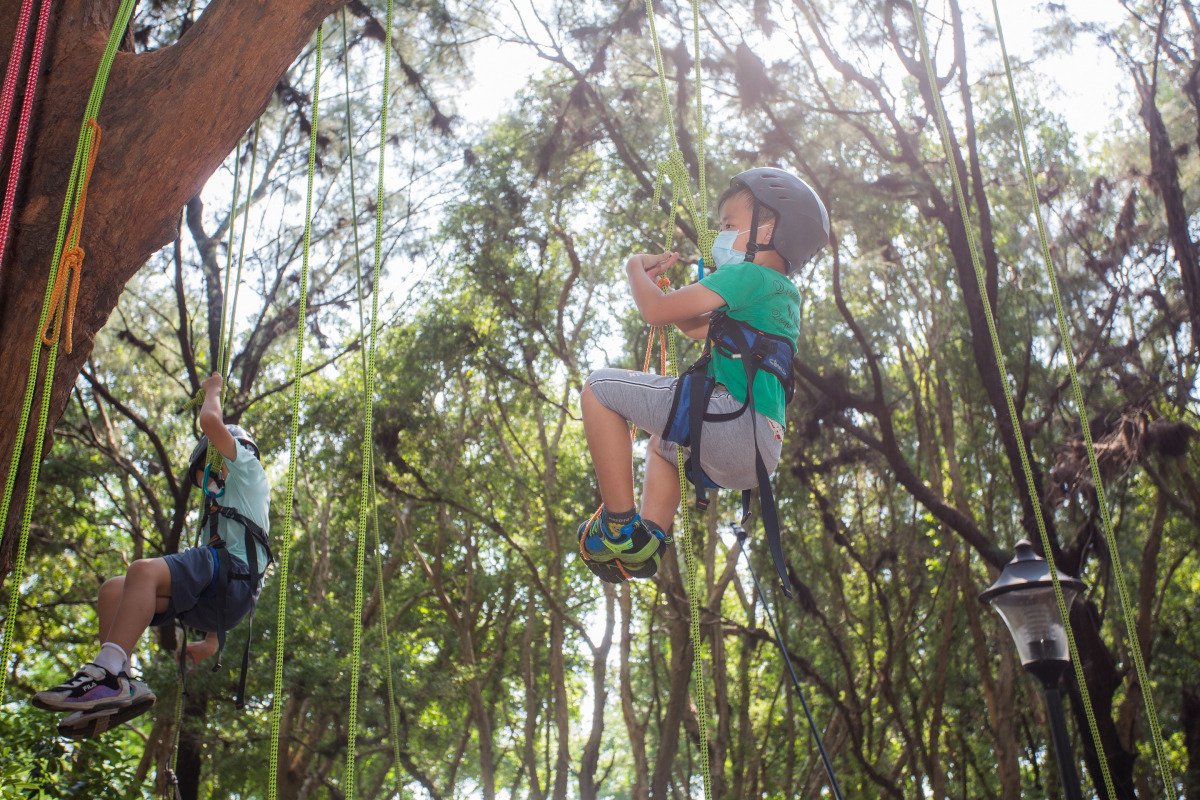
[911,0,1116,798]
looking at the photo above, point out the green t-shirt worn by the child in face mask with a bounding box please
[700,261,800,425]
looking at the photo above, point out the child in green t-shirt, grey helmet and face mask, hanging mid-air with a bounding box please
[578,168,829,583]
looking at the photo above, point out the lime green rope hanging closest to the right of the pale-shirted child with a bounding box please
[266,25,324,800]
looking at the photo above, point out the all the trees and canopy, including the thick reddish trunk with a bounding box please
[0,0,1200,800]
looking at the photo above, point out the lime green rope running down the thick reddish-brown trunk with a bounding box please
[0,0,137,702]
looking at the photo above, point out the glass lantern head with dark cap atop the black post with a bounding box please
[979,539,1086,684]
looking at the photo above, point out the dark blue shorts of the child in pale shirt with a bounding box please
[150,547,258,632]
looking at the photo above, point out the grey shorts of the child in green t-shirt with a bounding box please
[588,369,784,489]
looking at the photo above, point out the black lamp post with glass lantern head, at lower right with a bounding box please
[979,539,1085,800]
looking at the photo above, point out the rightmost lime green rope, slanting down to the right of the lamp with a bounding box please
[991,0,1178,798]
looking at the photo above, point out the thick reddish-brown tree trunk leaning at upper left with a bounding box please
[0,0,347,575]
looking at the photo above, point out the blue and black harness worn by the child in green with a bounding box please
[662,311,796,597]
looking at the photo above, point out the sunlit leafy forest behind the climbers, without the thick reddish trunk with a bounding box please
[0,2,1200,798]
